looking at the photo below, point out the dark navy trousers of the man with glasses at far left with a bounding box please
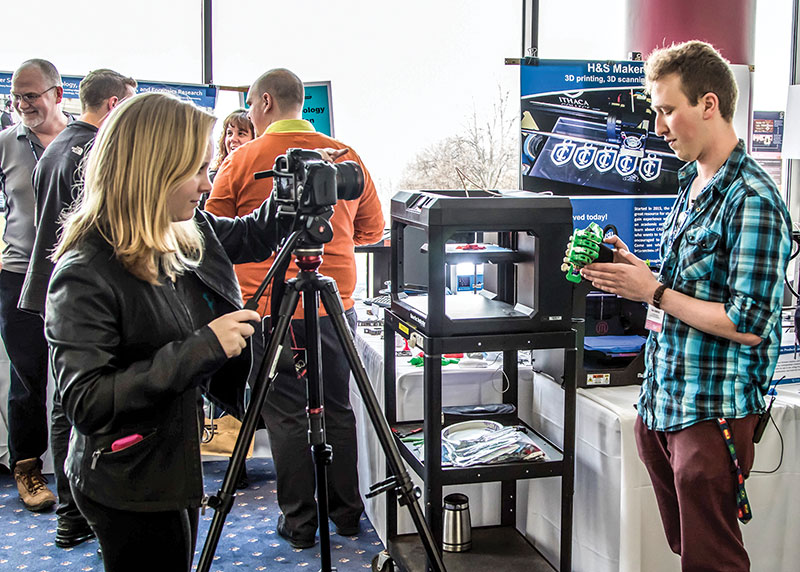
[0,270,47,470]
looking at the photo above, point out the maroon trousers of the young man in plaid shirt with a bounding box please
[634,415,758,572]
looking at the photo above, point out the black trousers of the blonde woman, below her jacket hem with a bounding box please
[72,482,200,572]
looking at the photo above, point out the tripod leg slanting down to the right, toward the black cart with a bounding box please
[319,277,445,572]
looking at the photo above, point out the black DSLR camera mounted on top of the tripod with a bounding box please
[256,149,364,214]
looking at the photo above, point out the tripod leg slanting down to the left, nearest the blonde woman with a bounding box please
[197,288,300,572]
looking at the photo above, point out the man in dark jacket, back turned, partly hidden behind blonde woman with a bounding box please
[19,69,136,548]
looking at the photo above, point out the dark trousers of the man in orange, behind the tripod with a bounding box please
[253,308,364,538]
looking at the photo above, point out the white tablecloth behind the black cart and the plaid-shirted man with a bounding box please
[351,322,800,572]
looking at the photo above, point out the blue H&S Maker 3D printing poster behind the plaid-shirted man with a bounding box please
[520,60,683,261]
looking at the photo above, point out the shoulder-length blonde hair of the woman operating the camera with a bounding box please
[53,93,215,284]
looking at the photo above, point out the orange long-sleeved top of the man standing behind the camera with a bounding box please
[206,119,384,318]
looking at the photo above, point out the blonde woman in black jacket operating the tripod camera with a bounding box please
[45,93,275,572]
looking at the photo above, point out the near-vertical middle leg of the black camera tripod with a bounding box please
[303,290,331,572]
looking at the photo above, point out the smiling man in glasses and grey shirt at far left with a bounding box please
[0,59,70,511]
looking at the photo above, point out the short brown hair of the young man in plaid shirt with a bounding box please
[644,40,739,122]
